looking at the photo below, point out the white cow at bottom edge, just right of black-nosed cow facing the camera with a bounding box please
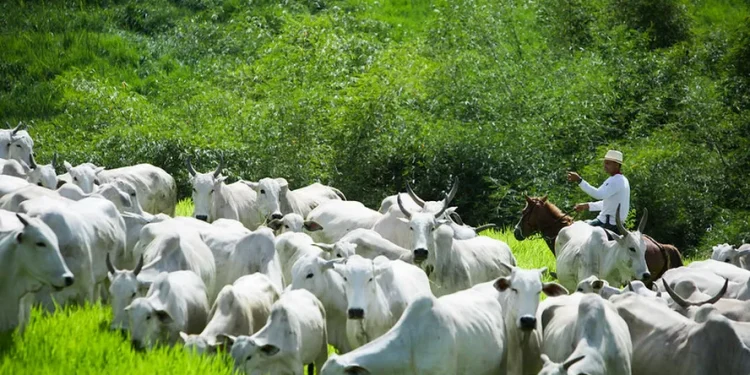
[537,293,633,375]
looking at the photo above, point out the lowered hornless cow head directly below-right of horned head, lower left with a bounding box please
[125,297,173,350]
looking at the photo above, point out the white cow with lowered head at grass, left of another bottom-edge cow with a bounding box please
[180,273,281,354]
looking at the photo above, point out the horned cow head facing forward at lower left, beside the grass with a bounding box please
[106,253,153,330]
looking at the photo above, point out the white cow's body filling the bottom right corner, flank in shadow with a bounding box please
[610,293,750,375]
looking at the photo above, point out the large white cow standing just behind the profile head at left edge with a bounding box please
[19,195,125,311]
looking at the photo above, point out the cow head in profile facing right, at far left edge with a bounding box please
[12,213,74,294]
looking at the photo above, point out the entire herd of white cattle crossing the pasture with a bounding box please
[0,125,750,375]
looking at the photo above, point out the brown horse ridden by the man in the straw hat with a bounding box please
[513,195,682,286]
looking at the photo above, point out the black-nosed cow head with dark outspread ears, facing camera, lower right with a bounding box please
[494,264,568,331]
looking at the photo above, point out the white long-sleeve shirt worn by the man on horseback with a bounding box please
[578,173,630,225]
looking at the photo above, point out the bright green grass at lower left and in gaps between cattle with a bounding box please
[0,200,555,375]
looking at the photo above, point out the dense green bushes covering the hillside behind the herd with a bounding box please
[0,0,750,258]
